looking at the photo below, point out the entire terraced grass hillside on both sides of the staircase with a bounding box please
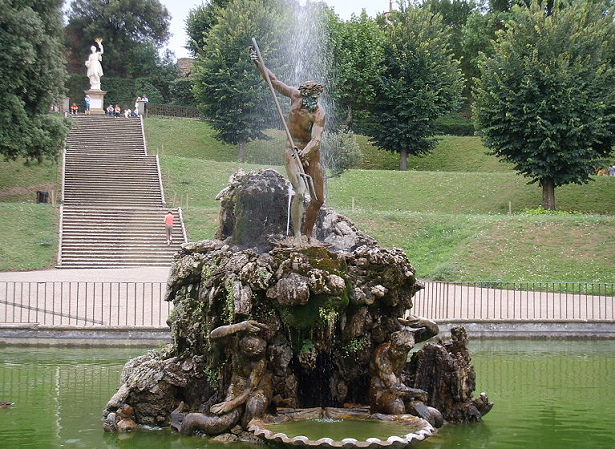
[0,114,615,282]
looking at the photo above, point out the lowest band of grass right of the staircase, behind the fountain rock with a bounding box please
[176,207,615,282]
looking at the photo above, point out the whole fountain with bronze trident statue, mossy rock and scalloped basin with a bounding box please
[104,0,492,440]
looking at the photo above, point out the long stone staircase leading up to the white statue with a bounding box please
[57,115,186,268]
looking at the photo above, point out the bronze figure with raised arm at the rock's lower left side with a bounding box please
[171,320,273,435]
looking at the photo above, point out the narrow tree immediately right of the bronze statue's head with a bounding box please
[327,10,384,127]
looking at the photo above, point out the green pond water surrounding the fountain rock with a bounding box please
[0,340,615,449]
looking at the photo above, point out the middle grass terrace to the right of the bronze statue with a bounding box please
[329,170,615,215]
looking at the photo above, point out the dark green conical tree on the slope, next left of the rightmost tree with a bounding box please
[367,2,463,170]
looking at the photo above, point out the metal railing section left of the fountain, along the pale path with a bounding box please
[0,281,172,328]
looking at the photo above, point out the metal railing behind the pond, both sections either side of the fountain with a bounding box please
[0,281,615,328]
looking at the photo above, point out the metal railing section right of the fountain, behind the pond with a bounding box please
[411,281,615,321]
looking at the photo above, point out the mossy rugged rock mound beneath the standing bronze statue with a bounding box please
[104,170,489,437]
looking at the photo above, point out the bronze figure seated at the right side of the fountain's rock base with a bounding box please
[369,316,443,427]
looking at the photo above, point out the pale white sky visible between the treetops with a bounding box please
[160,0,395,58]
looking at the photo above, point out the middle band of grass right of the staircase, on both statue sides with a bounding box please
[160,156,615,215]
